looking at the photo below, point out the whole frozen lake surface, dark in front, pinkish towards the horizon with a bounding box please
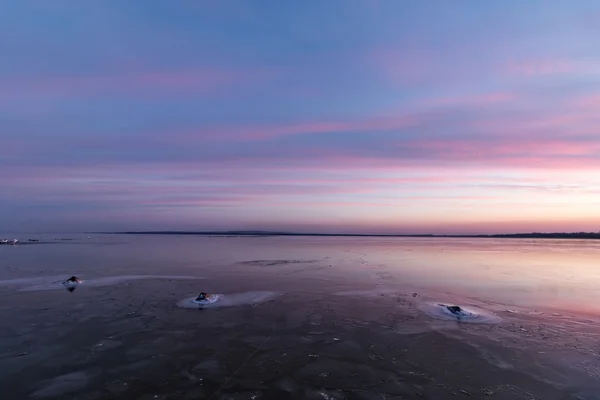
[0,234,600,399]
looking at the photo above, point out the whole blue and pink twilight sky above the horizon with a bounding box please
[0,0,600,233]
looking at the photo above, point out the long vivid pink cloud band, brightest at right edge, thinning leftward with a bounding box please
[0,134,600,173]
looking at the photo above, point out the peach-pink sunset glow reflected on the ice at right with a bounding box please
[356,239,600,312]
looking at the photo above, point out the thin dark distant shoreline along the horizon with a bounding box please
[110,231,600,239]
